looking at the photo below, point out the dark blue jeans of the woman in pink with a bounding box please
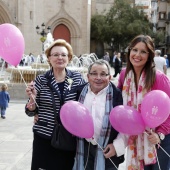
[144,134,170,170]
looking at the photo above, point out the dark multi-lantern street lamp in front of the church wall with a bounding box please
[36,23,51,52]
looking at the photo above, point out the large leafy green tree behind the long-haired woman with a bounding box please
[91,0,152,50]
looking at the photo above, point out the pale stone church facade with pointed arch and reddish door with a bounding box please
[0,0,114,56]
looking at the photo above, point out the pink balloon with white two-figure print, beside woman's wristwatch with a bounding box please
[141,90,170,128]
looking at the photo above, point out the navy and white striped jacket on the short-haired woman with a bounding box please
[26,69,85,139]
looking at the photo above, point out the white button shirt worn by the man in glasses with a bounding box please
[84,86,108,145]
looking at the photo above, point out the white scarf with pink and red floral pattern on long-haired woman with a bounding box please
[122,71,156,170]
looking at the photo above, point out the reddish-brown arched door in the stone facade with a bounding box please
[53,24,70,43]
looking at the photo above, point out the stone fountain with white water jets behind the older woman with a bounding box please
[6,53,98,83]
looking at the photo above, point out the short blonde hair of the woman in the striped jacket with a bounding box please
[45,39,73,66]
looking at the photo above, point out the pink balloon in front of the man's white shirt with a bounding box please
[60,101,94,138]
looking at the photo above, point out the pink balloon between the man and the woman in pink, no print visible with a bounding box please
[110,105,145,135]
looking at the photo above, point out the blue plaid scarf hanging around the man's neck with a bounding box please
[73,84,113,170]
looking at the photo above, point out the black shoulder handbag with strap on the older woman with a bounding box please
[49,79,76,151]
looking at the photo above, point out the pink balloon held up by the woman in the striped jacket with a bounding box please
[0,23,25,66]
